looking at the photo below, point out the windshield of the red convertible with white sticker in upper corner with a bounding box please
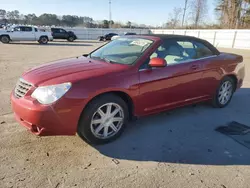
[89,38,153,65]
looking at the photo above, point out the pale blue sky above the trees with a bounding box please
[0,0,215,26]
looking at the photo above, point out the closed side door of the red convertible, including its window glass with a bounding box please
[137,40,203,114]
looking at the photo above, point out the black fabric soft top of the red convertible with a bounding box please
[142,34,220,55]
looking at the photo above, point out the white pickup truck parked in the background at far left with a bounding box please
[0,25,53,44]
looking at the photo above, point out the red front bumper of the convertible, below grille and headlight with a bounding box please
[11,93,81,136]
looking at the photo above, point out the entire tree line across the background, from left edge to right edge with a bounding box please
[0,0,250,29]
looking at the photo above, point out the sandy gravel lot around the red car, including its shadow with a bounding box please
[0,41,250,188]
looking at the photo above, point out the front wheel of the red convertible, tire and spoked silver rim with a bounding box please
[77,94,129,145]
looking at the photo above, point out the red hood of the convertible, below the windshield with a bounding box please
[22,57,128,85]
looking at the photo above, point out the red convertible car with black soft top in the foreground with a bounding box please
[11,35,245,144]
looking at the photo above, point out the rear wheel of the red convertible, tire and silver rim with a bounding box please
[212,77,236,108]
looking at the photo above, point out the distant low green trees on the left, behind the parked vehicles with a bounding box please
[0,9,148,28]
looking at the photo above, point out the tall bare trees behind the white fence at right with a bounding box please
[163,0,250,29]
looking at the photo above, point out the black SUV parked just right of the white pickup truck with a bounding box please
[51,28,77,42]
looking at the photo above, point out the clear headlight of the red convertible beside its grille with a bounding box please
[31,83,71,104]
